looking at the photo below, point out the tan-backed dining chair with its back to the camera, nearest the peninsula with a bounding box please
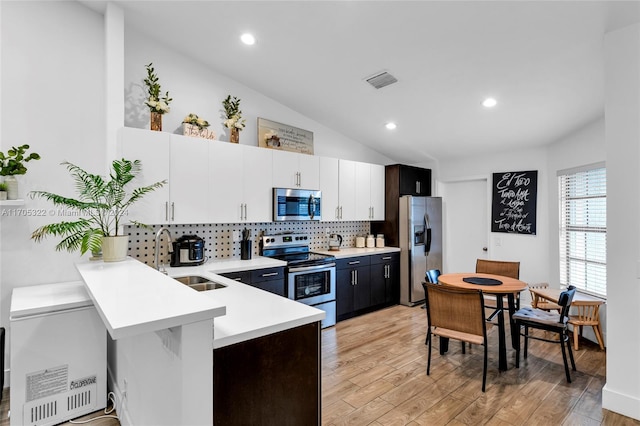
[422,283,487,392]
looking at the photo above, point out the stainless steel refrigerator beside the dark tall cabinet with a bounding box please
[399,195,442,306]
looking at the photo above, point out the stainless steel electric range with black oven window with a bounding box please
[260,233,336,328]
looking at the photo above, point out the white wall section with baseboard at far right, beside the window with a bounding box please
[602,24,640,420]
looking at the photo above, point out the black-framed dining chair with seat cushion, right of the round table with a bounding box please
[512,286,576,383]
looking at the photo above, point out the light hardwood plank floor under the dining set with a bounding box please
[0,306,640,426]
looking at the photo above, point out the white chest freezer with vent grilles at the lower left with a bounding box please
[9,281,107,426]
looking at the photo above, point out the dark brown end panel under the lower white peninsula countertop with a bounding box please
[213,322,321,426]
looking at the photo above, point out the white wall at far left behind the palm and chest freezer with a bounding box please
[0,2,104,386]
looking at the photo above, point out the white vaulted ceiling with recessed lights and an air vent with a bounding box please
[87,1,639,164]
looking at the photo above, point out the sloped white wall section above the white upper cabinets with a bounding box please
[120,27,392,164]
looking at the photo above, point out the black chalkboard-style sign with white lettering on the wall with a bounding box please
[491,170,538,235]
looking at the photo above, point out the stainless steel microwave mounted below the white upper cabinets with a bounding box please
[273,188,322,222]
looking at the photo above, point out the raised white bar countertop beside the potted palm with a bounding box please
[76,258,226,339]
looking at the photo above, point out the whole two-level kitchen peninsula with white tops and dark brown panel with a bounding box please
[77,258,324,425]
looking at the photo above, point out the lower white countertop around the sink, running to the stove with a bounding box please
[167,256,326,349]
